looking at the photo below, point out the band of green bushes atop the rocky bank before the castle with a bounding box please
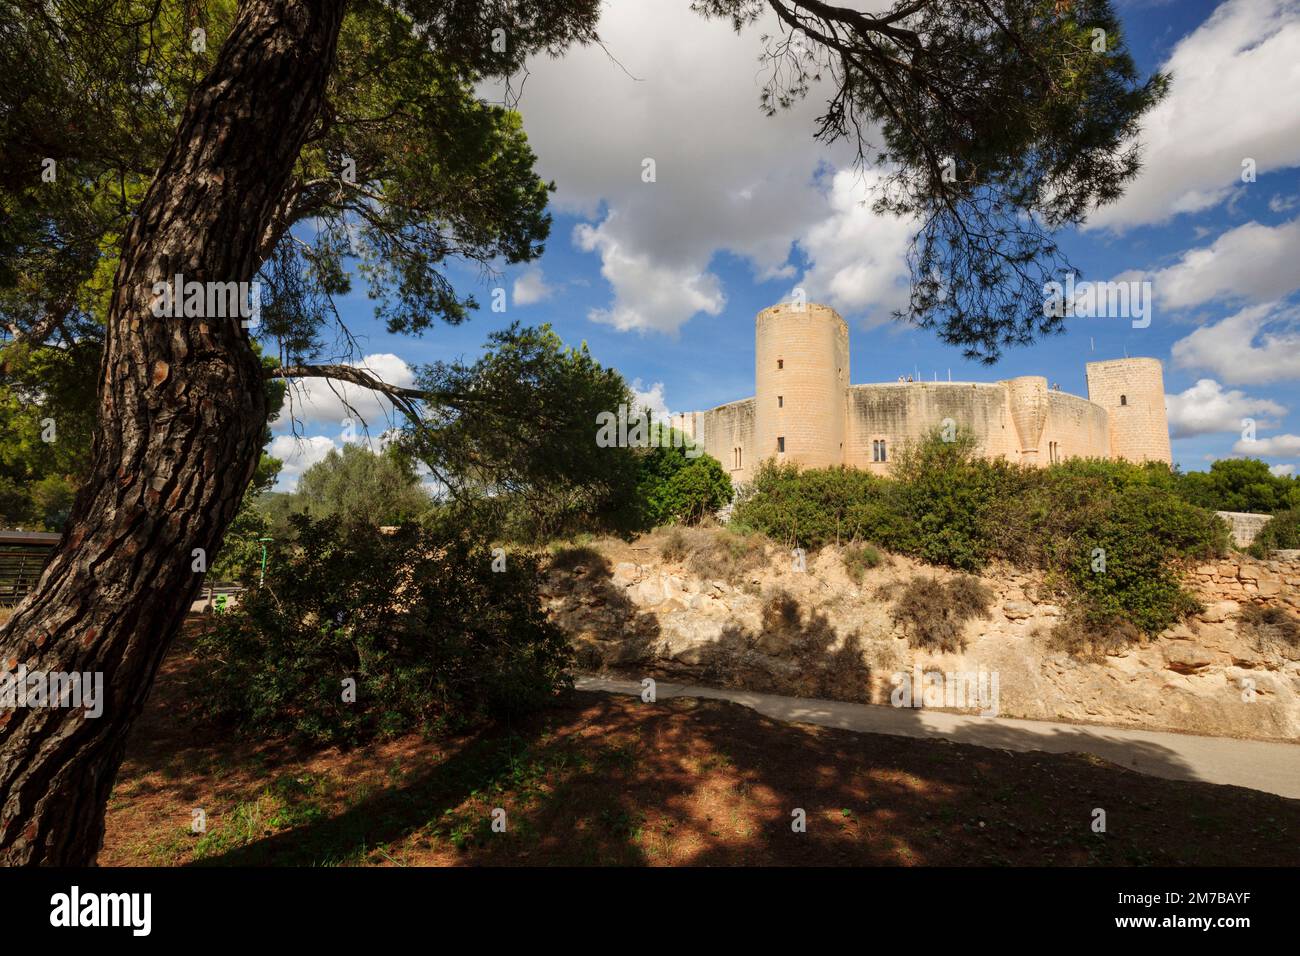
[733,433,1227,633]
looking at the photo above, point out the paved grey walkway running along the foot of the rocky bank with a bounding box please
[575,676,1300,800]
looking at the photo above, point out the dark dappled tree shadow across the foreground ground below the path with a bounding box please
[175,692,1300,866]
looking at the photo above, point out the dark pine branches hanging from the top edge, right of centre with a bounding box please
[693,0,1169,364]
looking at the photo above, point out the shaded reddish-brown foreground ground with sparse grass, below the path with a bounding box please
[99,624,1300,866]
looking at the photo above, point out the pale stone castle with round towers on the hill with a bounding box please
[672,303,1173,483]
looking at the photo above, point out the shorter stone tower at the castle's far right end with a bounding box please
[1087,359,1174,463]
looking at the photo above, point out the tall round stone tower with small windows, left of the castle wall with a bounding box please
[754,303,849,468]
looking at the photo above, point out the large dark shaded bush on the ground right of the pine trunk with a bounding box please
[199,515,569,743]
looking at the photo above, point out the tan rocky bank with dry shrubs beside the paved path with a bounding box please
[545,532,1300,740]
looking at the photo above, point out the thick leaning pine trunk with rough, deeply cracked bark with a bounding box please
[0,0,346,866]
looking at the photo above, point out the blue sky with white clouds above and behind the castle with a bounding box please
[273,0,1300,488]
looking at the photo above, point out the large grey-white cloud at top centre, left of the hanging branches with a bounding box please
[488,0,901,334]
